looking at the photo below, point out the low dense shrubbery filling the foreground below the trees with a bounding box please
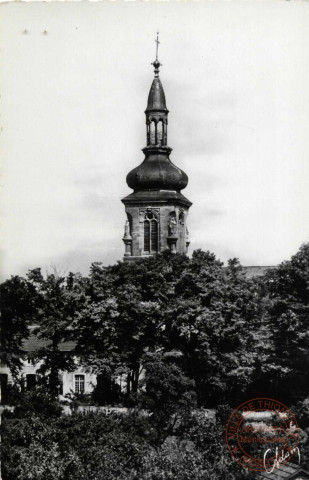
[2,394,248,480]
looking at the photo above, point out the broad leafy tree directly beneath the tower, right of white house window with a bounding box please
[75,253,189,395]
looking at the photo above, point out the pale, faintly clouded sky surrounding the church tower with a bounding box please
[0,0,309,278]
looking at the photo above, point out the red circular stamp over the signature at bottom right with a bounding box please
[225,398,300,473]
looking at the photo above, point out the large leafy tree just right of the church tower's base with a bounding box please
[161,250,268,406]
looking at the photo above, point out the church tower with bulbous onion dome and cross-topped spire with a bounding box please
[122,35,192,261]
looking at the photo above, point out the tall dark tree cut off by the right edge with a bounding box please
[260,243,309,402]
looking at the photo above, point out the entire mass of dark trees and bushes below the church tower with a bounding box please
[1,244,309,480]
